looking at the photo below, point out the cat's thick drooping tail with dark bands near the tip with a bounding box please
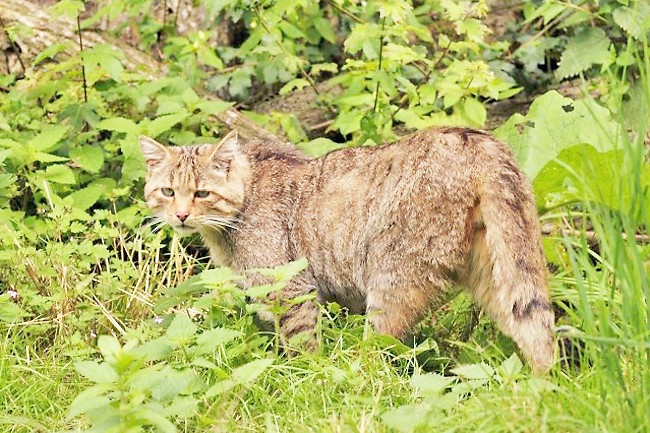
[468,154,554,373]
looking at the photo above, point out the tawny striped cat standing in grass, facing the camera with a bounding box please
[139,127,554,374]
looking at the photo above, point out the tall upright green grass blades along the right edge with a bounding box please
[565,40,650,432]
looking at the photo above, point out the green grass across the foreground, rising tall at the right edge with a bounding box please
[0,22,650,433]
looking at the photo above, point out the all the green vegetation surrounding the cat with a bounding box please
[0,0,650,433]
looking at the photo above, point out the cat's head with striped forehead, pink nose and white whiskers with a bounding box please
[139,131,250,235]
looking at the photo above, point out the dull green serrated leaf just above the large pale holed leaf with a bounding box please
[557,27,612,79]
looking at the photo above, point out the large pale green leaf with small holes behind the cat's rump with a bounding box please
[494,91,623,180]
